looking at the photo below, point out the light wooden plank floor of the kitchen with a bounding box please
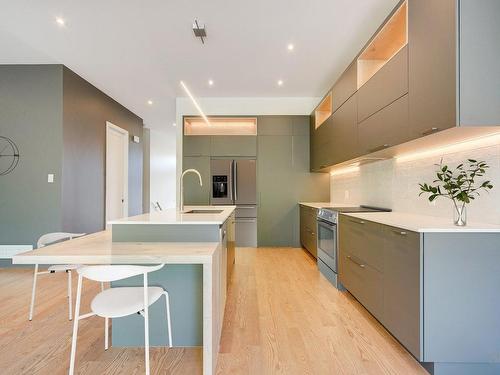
[0,248,427,375]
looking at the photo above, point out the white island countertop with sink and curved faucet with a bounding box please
[108,206,236,225]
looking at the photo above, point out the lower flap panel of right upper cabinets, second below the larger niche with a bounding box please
[358,94,410,154]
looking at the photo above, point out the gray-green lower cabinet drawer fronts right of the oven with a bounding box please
[338,215,422,359]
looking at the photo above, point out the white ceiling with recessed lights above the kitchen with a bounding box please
[0,0,397,128]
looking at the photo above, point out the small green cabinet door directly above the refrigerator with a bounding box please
[210,135,257,157]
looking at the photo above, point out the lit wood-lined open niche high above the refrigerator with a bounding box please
[184,116,257,135]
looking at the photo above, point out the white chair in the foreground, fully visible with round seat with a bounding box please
[69,264,172,375]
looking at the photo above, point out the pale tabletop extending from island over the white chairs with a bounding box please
[12,230,219,264]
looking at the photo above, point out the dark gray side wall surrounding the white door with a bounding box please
[62,67,143,233]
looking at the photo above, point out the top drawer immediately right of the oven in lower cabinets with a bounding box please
[339,215,384,271]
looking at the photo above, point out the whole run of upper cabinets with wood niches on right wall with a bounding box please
[310,0,500,172]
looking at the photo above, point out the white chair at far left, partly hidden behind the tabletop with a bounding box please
[29,232,85,320]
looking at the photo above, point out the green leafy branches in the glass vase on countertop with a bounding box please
[419,159,493,219]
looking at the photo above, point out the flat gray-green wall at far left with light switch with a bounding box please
[0,65,63,245]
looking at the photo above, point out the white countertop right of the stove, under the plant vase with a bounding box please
[342,212,500,233]
